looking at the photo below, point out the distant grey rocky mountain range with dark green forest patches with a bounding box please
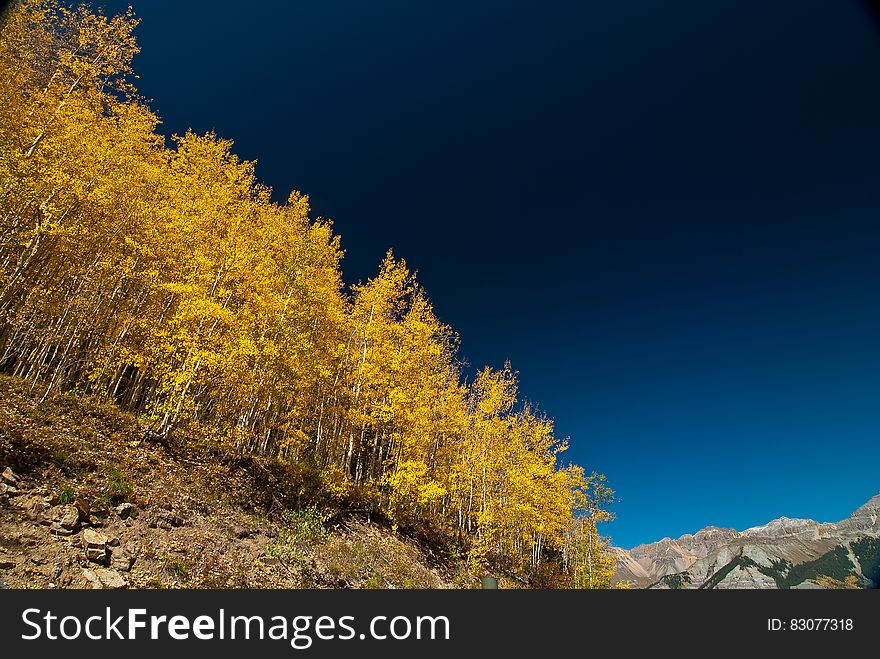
[614,494,880,588]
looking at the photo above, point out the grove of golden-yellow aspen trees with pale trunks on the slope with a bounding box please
[0,0,613,587]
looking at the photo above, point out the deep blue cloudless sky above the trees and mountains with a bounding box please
[95,0,880,547]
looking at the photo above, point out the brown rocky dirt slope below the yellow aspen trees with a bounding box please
[0,377,474,588]
